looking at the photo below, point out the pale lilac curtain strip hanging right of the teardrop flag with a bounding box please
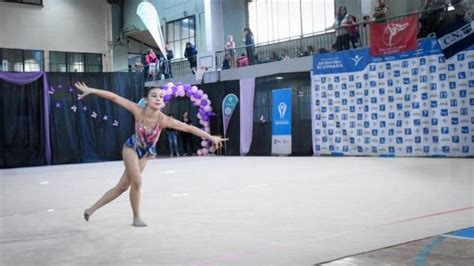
[240,78,255,155]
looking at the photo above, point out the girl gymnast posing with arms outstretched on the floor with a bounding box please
[74,82,227,227]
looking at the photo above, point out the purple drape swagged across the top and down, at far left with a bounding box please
[0,71,51,164]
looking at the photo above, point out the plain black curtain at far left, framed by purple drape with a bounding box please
[0,78,46,168]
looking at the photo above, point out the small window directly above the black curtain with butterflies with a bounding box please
[49,52,102,72]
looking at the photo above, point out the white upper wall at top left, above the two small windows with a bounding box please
[0,0,111,71]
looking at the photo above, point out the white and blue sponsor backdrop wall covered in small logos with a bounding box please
[311,39,474,157]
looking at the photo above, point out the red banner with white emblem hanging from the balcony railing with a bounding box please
[370,15,418,56]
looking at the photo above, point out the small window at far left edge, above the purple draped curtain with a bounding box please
[0,49,44,72]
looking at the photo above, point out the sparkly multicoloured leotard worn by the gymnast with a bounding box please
[124,122,161,159]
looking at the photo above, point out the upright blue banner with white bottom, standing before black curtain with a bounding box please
[272,88,292,155]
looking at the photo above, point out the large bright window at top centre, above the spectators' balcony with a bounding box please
[248,0,335,43]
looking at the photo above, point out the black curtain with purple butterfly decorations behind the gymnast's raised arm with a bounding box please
[48,73,144,164]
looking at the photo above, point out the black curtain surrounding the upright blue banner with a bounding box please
[248,72,313,156]
